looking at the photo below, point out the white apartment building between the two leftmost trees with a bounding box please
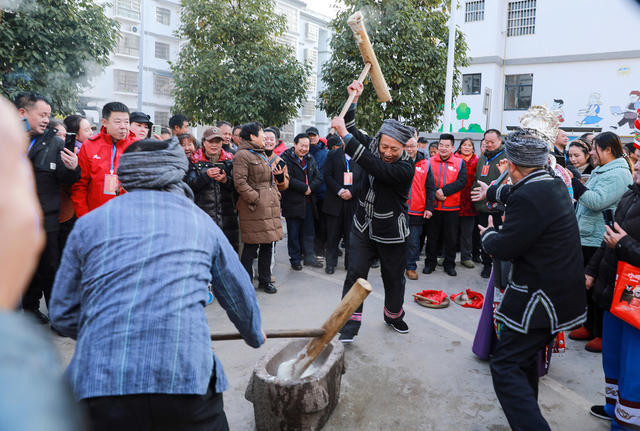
[81,0,180,126]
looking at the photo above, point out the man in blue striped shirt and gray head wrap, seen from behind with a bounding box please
[50,139,264,430]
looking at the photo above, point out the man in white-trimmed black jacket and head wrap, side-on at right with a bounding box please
[473,130,586,431]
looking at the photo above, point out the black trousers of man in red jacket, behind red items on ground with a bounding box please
[424,211,460,269]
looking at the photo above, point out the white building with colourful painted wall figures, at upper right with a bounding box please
[444,0,640,135]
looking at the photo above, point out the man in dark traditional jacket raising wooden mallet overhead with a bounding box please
[331,81,414,343]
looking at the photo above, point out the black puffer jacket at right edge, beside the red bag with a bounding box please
[585,184,640,310]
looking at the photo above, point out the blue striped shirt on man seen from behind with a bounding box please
[50,190,263,399]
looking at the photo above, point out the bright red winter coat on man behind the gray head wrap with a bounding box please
[71,127,138,217]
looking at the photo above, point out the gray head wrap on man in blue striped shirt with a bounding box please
[118,138,193,199]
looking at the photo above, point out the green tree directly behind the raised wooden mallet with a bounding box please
[320,0,467,133]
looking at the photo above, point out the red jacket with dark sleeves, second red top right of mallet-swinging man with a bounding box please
[429,153,467,211]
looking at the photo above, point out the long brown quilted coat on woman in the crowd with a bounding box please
[233,141,282,244]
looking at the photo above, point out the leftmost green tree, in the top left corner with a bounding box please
[0,0,119,114]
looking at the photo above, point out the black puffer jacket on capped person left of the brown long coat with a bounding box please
[185,160,239,251]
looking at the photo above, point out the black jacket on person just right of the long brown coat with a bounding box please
[280,147,322,223]
